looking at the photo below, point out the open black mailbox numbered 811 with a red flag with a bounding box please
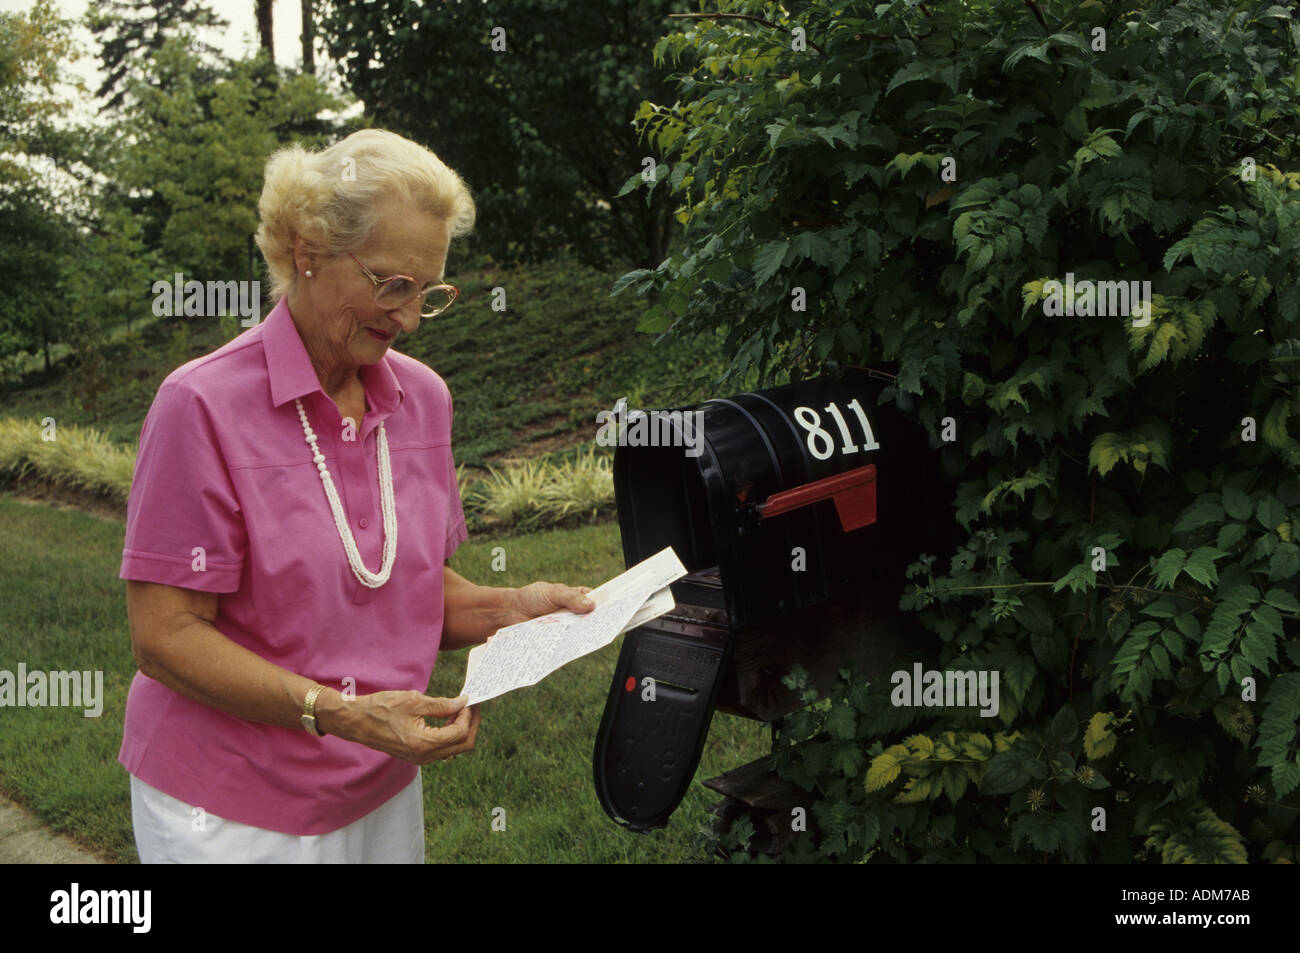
[593,369,952,831]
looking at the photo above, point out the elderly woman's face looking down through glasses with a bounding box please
[290,199,450,373]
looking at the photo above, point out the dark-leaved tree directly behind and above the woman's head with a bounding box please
[320,0,675,265]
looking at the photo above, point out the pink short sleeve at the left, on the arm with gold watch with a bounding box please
[118,380,247,593]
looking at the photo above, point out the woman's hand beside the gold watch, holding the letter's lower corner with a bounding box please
[316,690,478,764]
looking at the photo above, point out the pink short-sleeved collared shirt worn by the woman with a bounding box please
[118,299,467,835]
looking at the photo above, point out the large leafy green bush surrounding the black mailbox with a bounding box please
[619,0,1300,862]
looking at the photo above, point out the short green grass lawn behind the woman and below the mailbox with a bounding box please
[0,495,768,863]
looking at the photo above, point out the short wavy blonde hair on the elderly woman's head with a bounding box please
[256,129,476,300]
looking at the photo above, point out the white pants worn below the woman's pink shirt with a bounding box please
[131,775,424,863]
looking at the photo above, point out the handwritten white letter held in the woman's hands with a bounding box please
[460,547,686,705]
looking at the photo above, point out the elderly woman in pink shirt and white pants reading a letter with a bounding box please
[120,130,590,863]
